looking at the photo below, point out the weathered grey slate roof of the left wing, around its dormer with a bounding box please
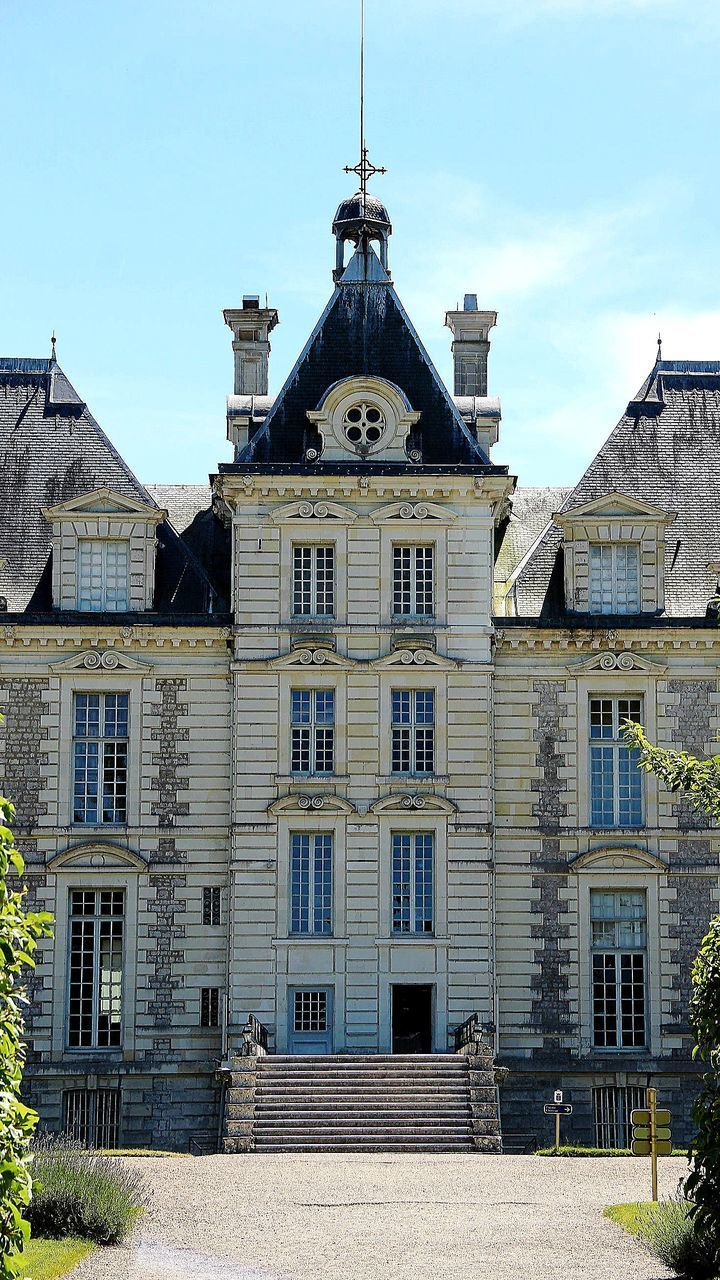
[0,357,227,617]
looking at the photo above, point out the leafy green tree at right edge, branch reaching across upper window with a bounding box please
[624,721,720,1268]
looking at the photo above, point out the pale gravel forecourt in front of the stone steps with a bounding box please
[72,1155,687,1280]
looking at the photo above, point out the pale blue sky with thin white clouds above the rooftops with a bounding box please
[0,0,720,484]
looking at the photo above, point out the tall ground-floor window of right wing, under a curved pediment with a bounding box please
[591,890,647,1048]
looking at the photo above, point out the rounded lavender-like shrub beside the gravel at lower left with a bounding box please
[28,1135,149,1244]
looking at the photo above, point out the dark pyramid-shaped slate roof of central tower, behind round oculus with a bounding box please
[220,246,507,475]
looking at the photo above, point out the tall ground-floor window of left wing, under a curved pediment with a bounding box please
[68,888,124,1048]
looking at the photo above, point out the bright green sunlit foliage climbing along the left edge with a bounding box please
[0,799,51,1280]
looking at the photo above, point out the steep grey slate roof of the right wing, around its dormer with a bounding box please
[507,360,720,623]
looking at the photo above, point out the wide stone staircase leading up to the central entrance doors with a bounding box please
[223,1053,501,1152]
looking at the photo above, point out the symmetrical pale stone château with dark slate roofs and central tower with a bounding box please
[0,193,720,1149]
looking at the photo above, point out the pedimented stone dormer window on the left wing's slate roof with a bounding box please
[42,489,168,613]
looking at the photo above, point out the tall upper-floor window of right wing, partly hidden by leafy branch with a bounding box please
[589,698,643,827]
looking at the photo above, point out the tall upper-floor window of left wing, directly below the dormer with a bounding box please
[73,694,128,823]
